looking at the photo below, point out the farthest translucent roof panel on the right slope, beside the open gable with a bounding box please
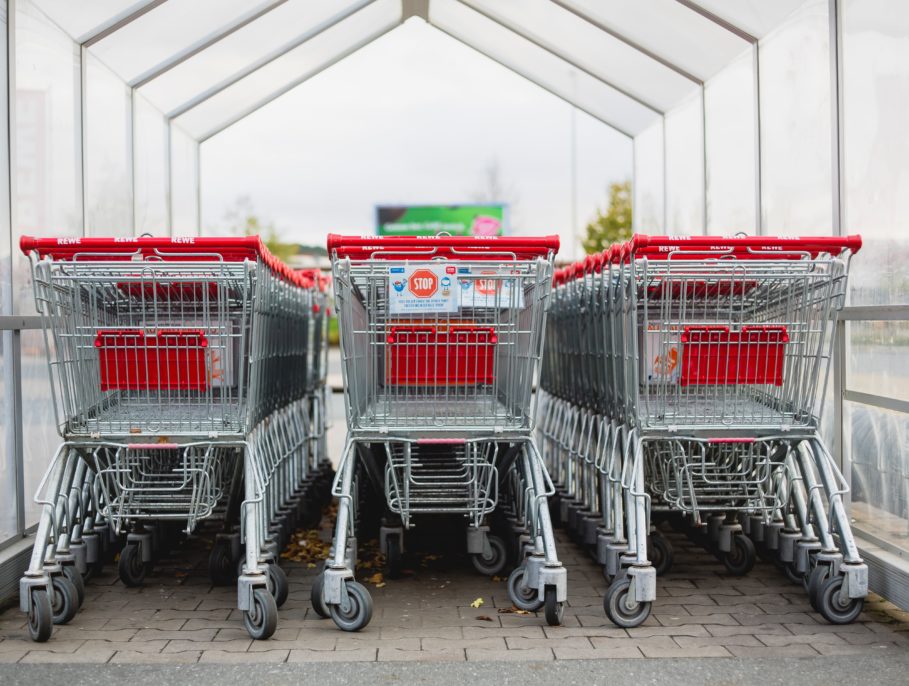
[429,0,660,136]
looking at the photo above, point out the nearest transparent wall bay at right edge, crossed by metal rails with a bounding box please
[841,0,909,551]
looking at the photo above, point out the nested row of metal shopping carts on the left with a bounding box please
[20,237,327,641]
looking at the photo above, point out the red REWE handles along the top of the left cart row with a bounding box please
[19,236,314,288]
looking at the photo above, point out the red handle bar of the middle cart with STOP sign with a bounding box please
[328,233,559,260]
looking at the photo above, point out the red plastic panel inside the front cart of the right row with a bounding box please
[679,326,789,386]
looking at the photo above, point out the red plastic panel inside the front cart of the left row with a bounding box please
[95,329,208,391]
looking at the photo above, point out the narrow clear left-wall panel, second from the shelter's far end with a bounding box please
[133,93,170,236]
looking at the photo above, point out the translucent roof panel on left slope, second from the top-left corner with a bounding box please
[88,0,274,83]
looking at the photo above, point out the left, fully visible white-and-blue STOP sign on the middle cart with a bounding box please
[388,265,458,314]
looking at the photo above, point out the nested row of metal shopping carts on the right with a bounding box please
[539,235,868,626]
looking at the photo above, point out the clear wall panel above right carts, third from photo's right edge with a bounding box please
[704,50,757,234]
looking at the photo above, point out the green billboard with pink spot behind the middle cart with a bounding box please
[376,205,508,236]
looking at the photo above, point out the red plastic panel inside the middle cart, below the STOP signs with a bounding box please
[385,326,498,386]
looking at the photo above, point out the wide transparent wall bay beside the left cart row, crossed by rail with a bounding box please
[11,0,82,527]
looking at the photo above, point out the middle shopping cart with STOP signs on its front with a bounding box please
[312,236,566,631]
